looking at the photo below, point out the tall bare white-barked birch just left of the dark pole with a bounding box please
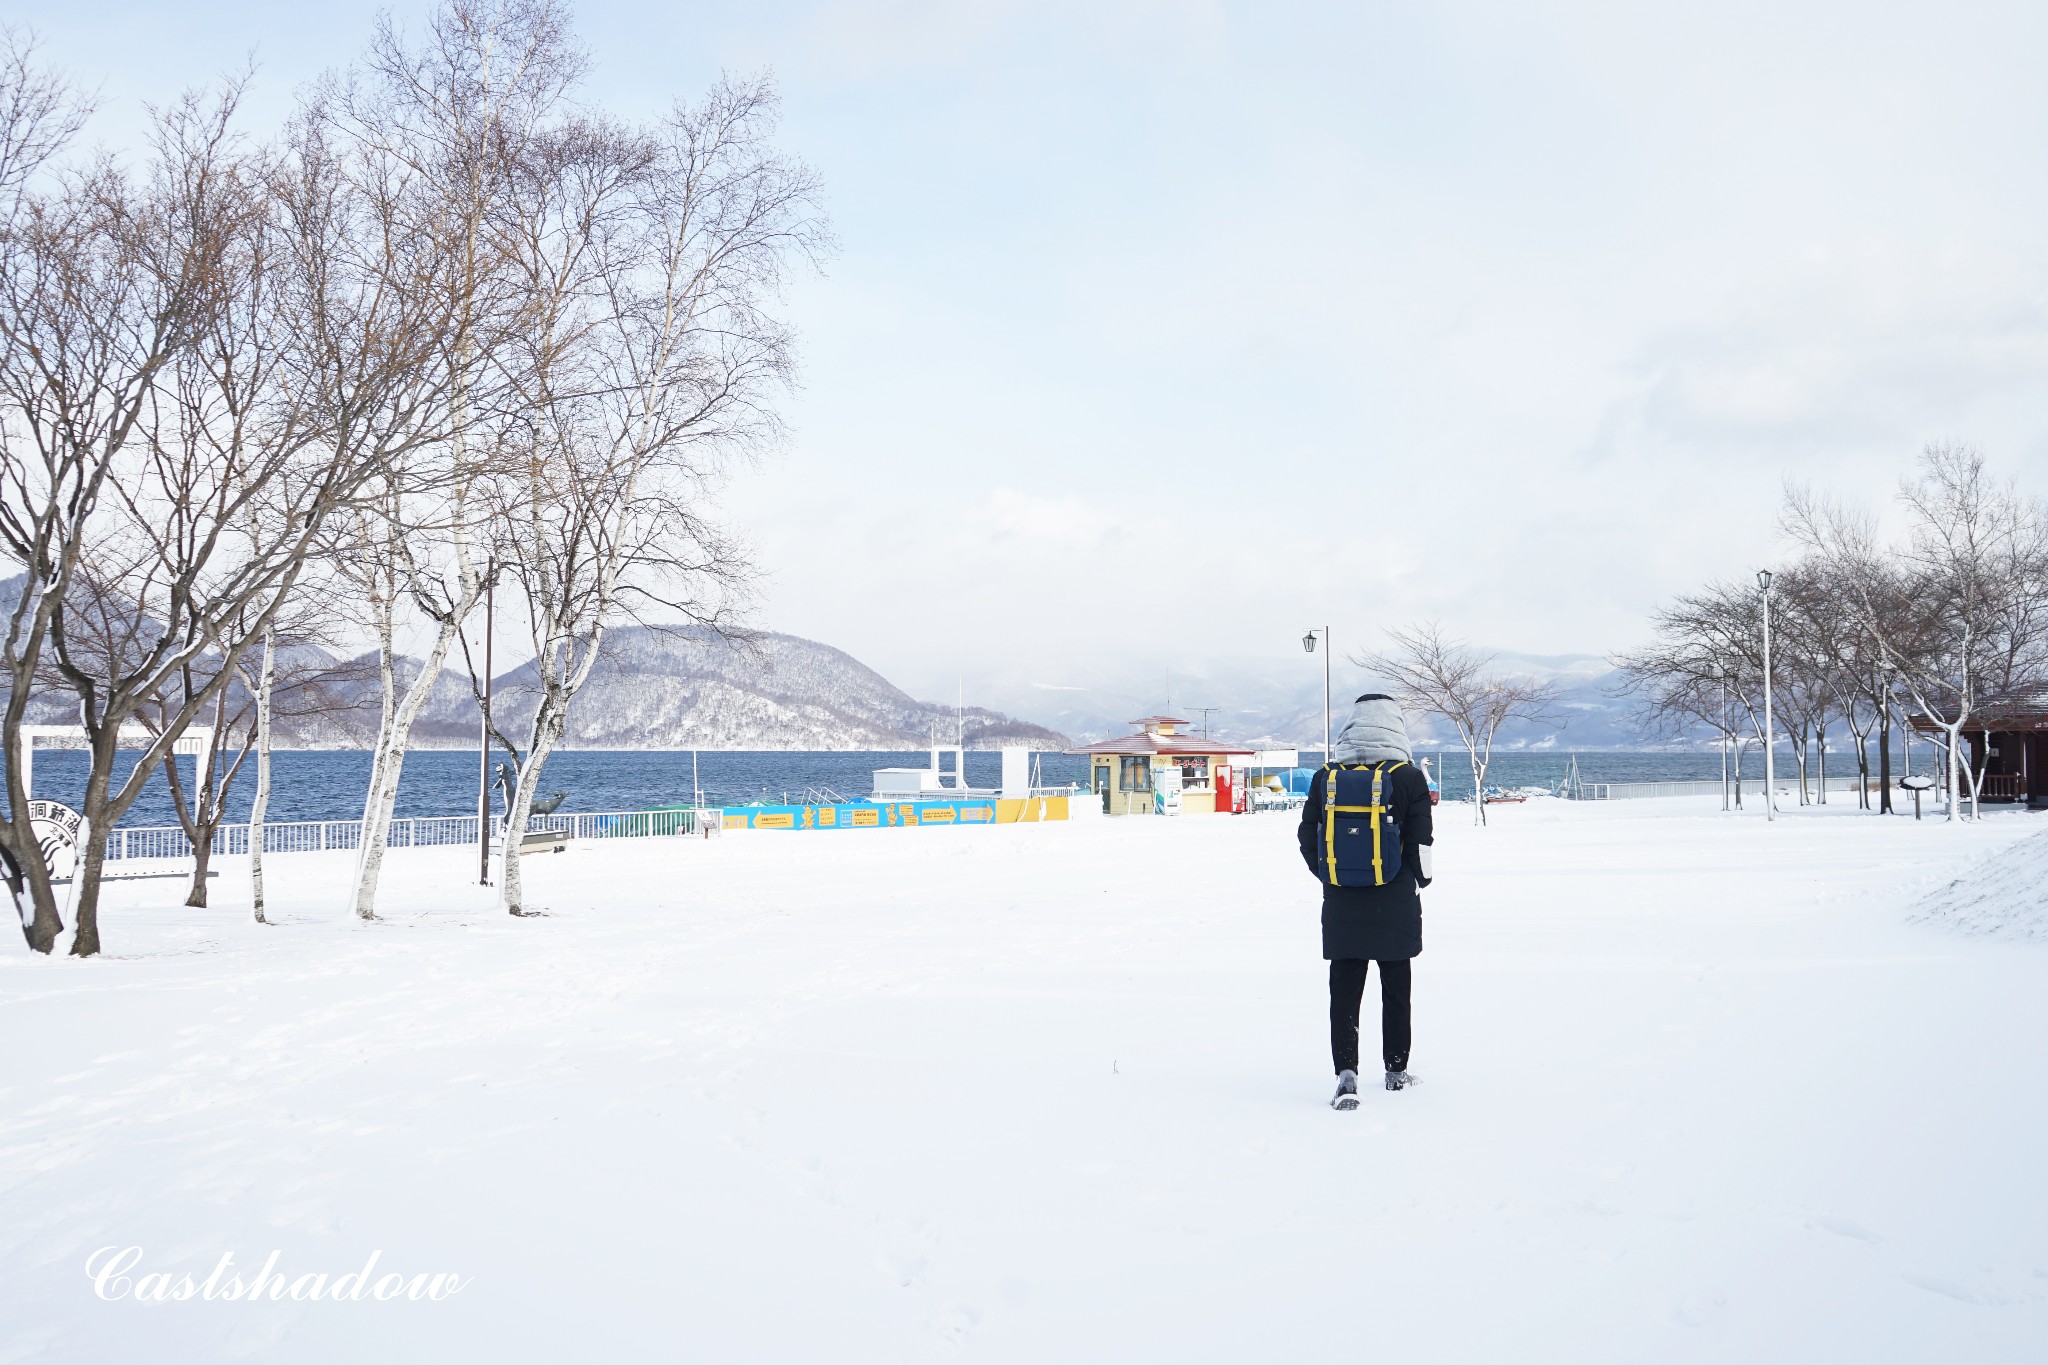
[305,0,584,919]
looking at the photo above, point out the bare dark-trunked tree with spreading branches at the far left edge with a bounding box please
[0,61,466,956]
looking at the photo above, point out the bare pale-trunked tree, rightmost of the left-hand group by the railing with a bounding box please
[498,80,827,915]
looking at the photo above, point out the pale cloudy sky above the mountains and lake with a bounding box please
[16,0,2048,700]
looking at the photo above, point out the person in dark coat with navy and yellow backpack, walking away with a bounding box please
[1298,692,1436,1109]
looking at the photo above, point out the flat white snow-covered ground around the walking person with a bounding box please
[0,800,2048,1363]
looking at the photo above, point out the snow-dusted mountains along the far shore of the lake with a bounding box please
[0,560,1657,751]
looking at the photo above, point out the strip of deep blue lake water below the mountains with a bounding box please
[12,749,1884,827]
